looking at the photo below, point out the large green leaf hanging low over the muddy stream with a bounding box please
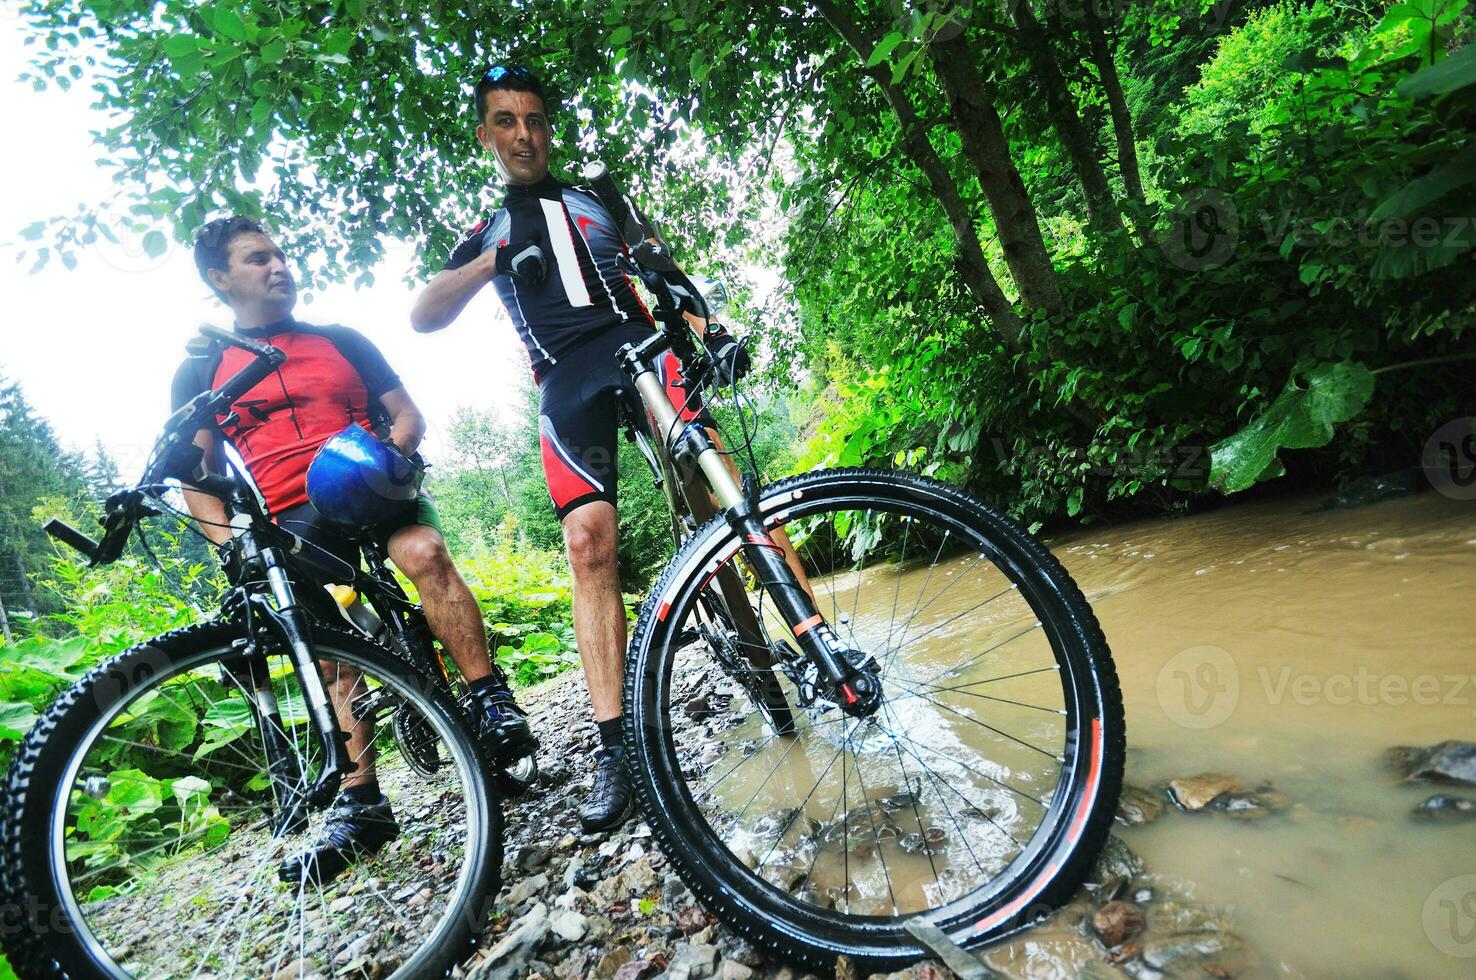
[1209,360,1374,493]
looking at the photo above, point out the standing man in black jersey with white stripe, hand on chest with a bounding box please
[410,65,755,831]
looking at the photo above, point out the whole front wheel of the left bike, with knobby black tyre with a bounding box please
[0,623,502,977]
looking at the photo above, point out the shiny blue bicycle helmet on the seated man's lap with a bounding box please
[307,425,422,528]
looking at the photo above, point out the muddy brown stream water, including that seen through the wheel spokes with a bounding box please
[694,494,1476,977]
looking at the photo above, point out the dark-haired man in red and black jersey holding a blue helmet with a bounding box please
[173,217,537,883]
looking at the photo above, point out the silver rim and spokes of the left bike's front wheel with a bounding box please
[49,631,497,977]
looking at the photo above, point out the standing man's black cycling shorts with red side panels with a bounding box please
[539,323,714,521]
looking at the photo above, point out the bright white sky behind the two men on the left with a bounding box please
[0,22,528,480]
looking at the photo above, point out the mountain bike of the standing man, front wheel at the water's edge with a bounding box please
[584,164,1125,970]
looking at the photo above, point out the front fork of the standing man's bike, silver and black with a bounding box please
[627,362,881,717]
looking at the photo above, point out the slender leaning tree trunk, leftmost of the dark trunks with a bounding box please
[815,0,1026,353]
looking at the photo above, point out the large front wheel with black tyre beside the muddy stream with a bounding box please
[627,472,1120,961]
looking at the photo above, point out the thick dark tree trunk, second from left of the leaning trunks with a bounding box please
[928,31,1061,313]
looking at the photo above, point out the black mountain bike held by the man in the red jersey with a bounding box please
[0,328,501,977]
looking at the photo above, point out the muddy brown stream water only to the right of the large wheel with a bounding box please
[1052,494,1476,977]
